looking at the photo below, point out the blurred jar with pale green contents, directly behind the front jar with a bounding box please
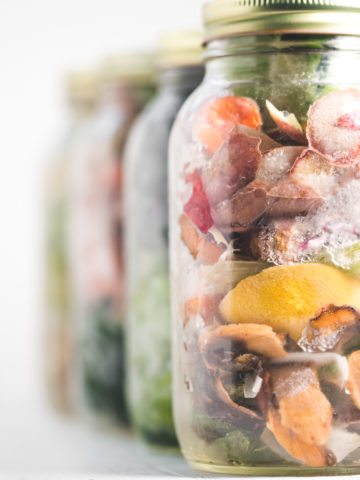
[125,32,203,446]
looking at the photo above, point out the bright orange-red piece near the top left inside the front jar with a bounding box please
[194,95,262,153]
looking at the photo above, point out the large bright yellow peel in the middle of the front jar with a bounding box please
[220,263,360,341]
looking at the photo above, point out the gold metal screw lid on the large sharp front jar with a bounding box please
[203,0,360,43]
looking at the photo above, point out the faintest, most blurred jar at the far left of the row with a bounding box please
[44,71,98,413]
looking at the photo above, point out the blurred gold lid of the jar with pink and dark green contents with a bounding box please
[100,51,155,84]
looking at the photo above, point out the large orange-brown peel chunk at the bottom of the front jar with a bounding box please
[268,364,336,466]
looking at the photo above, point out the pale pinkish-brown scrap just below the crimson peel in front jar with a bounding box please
[179,214,225,265]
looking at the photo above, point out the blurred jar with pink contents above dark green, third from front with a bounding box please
[69,54,154,424]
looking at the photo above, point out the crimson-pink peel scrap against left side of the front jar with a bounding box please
[184,170,214,233]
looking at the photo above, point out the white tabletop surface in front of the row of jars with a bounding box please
[0,398,355,480]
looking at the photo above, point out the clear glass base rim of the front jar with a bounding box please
[188,460,360,477]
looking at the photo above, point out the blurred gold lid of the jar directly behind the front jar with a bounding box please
[158,30,203,69]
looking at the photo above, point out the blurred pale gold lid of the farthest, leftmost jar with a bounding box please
[65,70,99,104]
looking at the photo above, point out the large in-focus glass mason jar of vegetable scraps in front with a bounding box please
[170,0,360,475]
